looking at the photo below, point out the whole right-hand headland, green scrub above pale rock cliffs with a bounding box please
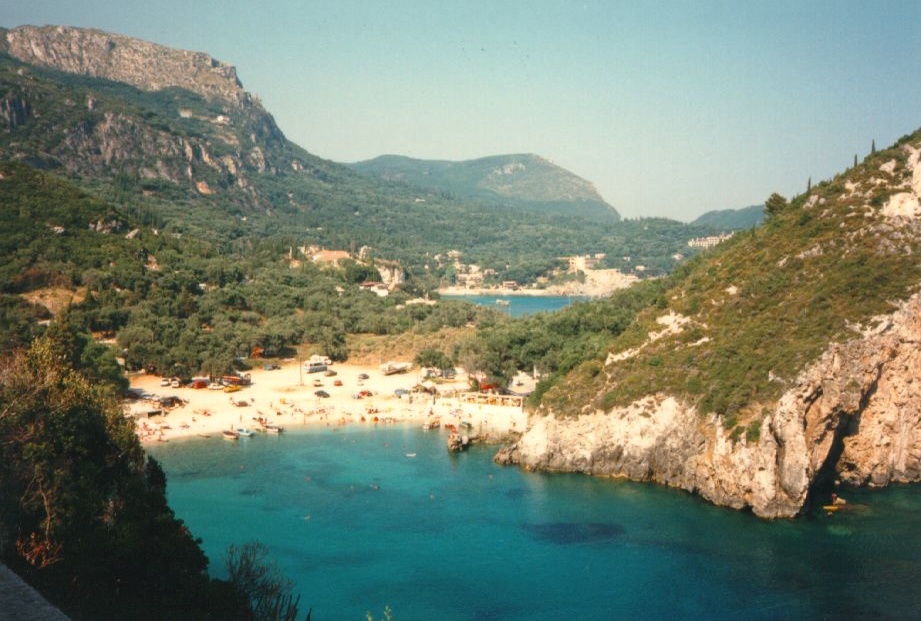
[496,134,921,517]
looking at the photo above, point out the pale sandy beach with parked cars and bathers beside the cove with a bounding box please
[126,360,527,443]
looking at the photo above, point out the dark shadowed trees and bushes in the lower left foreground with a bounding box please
[0,338,247,619]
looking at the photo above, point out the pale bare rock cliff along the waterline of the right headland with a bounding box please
[496,294,921,518]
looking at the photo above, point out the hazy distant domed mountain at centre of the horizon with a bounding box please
[348,154,620,223]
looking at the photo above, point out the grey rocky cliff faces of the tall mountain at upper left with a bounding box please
[0,26,309,206]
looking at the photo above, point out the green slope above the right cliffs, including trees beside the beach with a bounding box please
[468,132,921,433]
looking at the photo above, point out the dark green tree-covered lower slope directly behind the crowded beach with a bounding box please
[0,162,510,375]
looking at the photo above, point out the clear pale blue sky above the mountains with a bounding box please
[0,0,921,221]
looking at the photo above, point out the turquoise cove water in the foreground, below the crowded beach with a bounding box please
[153,426,921,621]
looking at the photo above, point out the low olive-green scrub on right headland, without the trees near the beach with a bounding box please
[543,135,921,424]
